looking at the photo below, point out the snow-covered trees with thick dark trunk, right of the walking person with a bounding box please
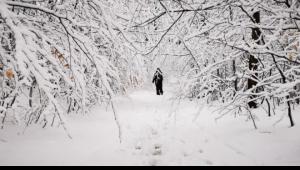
[127,0,300,126]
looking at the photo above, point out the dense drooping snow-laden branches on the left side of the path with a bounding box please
[0,0,143,131]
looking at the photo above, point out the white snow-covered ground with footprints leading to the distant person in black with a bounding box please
[0,85,300,166]
